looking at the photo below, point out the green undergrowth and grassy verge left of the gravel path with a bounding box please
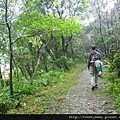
[0,64,84,114]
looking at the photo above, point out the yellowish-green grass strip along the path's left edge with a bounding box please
[7,64,85,114]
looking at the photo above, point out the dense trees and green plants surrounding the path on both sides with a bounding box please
[0,0,120,113]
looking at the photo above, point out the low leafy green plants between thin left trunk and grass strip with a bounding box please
[13,71,63,98]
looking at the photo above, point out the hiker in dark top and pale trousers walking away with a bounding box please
[88,45,102,90]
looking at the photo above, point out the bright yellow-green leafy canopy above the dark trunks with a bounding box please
[14,11,82,40]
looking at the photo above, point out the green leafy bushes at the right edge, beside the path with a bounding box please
[104,59,120,113]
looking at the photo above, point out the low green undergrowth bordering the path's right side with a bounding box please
[103,68,120,113]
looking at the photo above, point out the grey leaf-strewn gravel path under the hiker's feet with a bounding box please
[45,70,117,114]
